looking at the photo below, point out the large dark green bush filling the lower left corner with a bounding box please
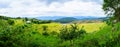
[0,23,40,47]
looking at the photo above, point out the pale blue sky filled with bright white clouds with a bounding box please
[0,0,105,17]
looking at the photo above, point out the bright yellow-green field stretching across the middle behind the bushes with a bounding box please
[15,20,106,33]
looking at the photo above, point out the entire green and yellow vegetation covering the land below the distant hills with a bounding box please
[0,15,120,47]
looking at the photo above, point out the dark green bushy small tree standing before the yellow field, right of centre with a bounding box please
[60,24,86,40]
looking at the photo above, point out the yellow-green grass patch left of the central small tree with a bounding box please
[32,23,62,33]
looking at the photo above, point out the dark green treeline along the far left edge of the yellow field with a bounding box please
[0,16,53,24]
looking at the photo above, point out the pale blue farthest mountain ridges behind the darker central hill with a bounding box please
[36,16,106,20]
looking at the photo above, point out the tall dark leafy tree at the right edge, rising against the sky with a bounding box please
[103,0,120,22]
